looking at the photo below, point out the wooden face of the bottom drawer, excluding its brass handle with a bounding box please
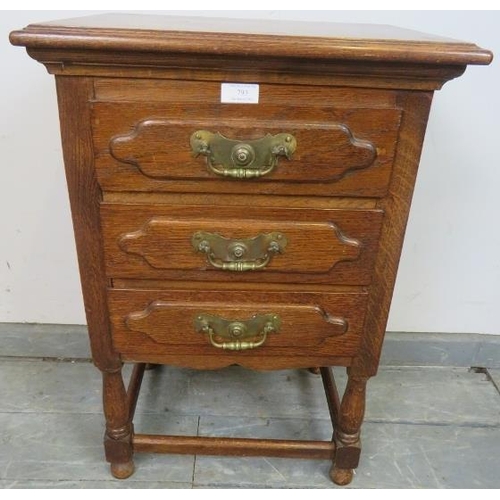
[109,289,366,366]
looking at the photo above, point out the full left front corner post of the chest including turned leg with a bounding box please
[56,75,134,478]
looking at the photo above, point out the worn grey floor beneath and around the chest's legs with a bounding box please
[0,324,500,488]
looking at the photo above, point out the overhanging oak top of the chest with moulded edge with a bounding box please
[10,14,493,65]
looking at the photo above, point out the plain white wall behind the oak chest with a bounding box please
[0,11,500,334]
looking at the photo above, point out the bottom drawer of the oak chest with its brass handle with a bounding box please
[109,289,367,368]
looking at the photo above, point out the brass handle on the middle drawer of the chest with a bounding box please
[191,231,287,271]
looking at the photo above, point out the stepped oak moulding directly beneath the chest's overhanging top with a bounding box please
[36,56,466,90]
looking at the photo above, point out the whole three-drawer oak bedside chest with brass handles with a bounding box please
[10,15,492,484]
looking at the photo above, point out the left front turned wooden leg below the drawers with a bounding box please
[103,368,134,479]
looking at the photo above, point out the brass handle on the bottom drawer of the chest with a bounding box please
[194,314,281,351]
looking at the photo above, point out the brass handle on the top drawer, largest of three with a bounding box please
[190,130,297,179]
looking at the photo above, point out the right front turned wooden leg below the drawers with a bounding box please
[330,369,368,485]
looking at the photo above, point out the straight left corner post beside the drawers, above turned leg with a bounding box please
[56,77,121,370]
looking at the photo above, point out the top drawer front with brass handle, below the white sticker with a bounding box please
[93,103,401,196]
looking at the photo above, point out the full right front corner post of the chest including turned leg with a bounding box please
[331,91,433,484]
